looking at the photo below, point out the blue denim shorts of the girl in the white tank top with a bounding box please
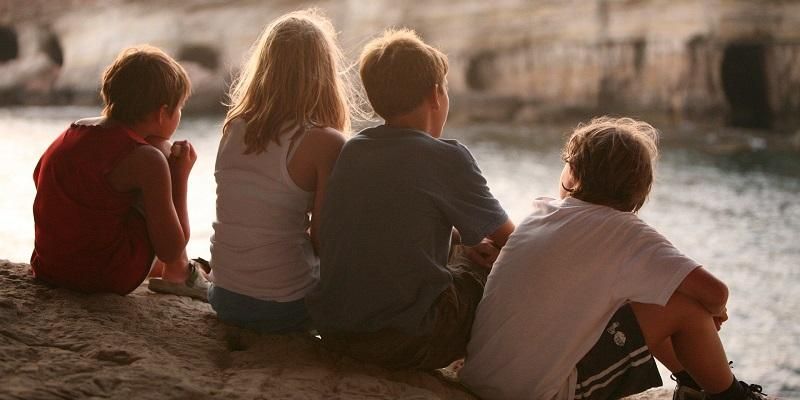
[208,284,310,333]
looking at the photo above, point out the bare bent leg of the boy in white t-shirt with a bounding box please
[631,293,733,393]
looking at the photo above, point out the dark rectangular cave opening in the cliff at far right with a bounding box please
[721,43,772,129]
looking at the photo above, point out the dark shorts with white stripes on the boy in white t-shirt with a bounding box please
[575,305,662,400]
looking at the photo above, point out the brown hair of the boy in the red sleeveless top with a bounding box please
[100,45,192,124]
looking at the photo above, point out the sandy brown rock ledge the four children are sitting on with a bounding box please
[0,260,670,400]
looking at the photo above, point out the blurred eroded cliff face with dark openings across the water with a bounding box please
[0,0,800,128]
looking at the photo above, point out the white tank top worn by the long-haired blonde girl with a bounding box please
[211,119,319,302]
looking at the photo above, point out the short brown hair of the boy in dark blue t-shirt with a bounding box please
[359,29,448,119]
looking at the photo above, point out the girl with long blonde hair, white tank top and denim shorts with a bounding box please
[209,9,355,333]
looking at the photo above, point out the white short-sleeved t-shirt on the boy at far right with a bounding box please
[460,197,699,400]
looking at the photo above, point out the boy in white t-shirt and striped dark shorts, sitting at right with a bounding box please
[460,117,764,400]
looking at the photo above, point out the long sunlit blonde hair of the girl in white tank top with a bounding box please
[223,8,357,154]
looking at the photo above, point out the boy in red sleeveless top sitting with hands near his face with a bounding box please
[31,46,207,298]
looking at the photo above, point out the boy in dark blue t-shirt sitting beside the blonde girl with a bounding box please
[307,30,514,369]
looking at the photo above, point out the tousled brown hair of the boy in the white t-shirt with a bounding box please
[561,117,658,212]
